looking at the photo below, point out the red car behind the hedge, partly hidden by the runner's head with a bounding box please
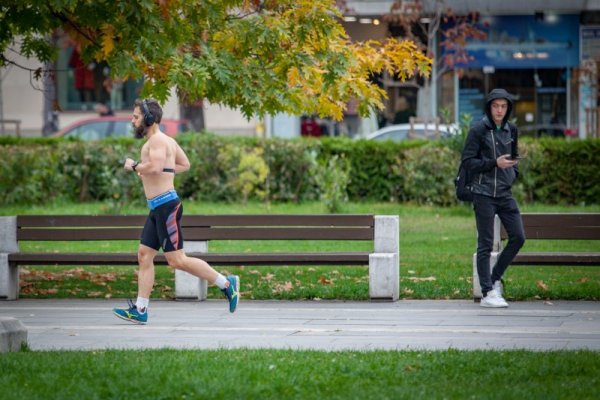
[53,116,189,141]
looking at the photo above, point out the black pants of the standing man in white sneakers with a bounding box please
[473,195,525,297]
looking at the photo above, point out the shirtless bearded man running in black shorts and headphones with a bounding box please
[113,99,240,324]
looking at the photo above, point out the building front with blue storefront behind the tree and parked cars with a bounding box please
[0,0,600,137]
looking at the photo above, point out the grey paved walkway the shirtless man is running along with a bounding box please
[0,300,600,350]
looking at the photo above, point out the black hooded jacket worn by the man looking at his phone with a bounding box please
[461,89,519,198]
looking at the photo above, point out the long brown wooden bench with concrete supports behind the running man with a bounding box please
[0,215,400,301]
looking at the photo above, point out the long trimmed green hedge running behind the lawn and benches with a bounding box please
[0,134,600,208]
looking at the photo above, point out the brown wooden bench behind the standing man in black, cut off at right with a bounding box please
[473,213,600,299]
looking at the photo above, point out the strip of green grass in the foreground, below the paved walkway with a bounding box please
[0,349,600,400]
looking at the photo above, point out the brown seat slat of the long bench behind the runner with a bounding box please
[8,252,369,265]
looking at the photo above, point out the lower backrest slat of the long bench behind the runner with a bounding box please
[17,227,374,241]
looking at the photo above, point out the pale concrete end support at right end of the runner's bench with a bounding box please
[369,215,400,301]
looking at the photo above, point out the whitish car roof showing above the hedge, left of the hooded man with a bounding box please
[362,123,458,142]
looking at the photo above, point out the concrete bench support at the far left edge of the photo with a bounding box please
[0,217,19,300]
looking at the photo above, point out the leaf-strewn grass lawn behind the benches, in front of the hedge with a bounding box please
[0,202,600,300]
